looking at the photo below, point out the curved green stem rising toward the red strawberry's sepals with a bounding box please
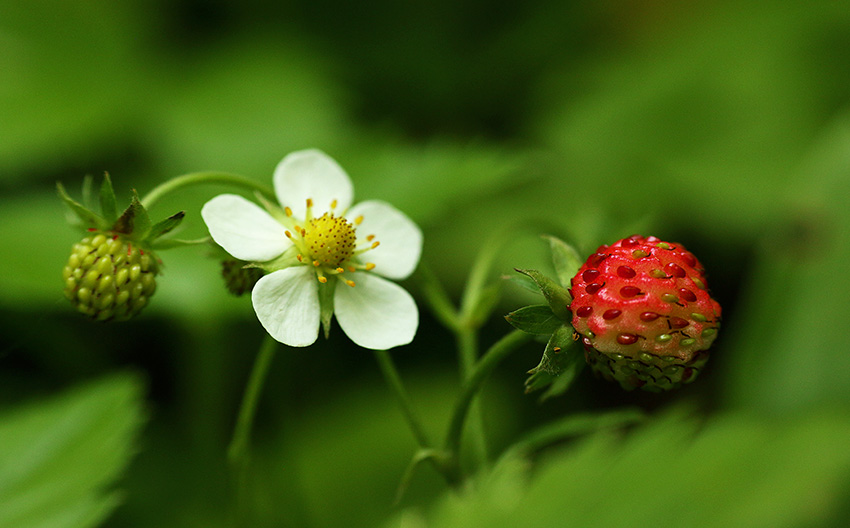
[445,330,532,458]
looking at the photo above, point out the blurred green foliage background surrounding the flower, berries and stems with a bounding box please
[0,0,850,527]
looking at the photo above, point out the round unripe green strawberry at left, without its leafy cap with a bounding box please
[62,230,159,321]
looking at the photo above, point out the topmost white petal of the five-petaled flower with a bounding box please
[274,149,354,219]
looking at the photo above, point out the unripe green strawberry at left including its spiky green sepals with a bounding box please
[57,174,184,321]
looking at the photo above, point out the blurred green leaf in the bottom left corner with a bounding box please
[0,376,143,528]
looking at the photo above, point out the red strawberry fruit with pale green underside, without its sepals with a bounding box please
[570,235,720,391]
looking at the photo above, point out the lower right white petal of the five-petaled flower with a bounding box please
[334,273,419,350]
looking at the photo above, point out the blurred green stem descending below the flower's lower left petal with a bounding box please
[227,335,277,510]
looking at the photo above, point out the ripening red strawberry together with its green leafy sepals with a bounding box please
[508,235,721,396]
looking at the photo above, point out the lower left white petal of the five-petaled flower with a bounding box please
[251,266,319,347]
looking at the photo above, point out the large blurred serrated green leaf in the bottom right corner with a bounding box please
[422,407,850,528]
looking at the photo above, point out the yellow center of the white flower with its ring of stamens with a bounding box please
[284,198,380,286]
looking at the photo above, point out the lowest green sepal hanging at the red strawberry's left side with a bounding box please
[525,325,585,401]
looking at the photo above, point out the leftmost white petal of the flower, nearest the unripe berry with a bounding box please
[201,194,292,262]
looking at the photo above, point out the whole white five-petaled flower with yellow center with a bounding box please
[201,150,422,350]
